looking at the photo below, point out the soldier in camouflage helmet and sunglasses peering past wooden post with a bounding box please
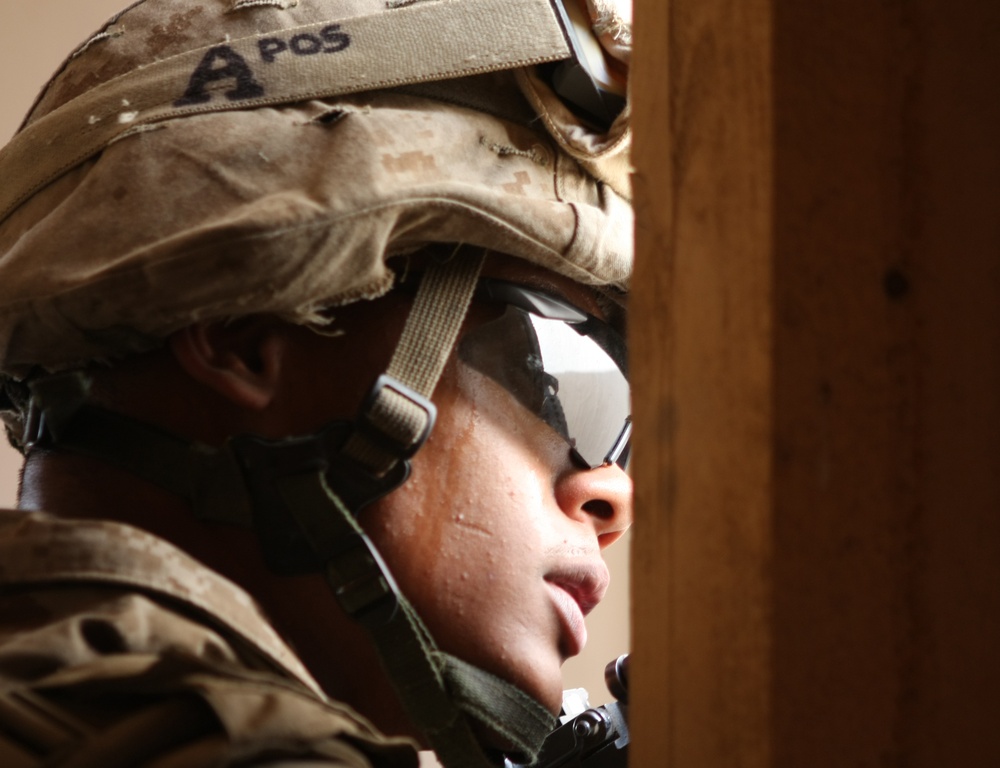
[0,0,631,768]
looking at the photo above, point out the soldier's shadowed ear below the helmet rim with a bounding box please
[169,316,287,410]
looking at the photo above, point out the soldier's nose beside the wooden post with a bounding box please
[555,464,632,549]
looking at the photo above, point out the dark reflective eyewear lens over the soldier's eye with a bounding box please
[458,306,631,468]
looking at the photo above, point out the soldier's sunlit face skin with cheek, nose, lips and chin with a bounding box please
[362,267,632,711]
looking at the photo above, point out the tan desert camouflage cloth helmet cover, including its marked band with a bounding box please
[0,0,632,384]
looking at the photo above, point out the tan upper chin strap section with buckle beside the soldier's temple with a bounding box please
[344,249,485,475]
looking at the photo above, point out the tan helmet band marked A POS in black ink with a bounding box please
[0,0,570,222]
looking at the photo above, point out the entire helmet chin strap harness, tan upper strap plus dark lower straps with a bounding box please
[26,253,555,768]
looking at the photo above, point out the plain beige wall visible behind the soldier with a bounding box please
[0,0,629,702]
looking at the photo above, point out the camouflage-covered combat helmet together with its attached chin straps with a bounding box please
[0,0,632,765]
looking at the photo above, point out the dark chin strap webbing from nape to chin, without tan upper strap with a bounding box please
[23,374,555,768]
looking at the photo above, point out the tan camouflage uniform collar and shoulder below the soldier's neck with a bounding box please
[0,512,417,768]
